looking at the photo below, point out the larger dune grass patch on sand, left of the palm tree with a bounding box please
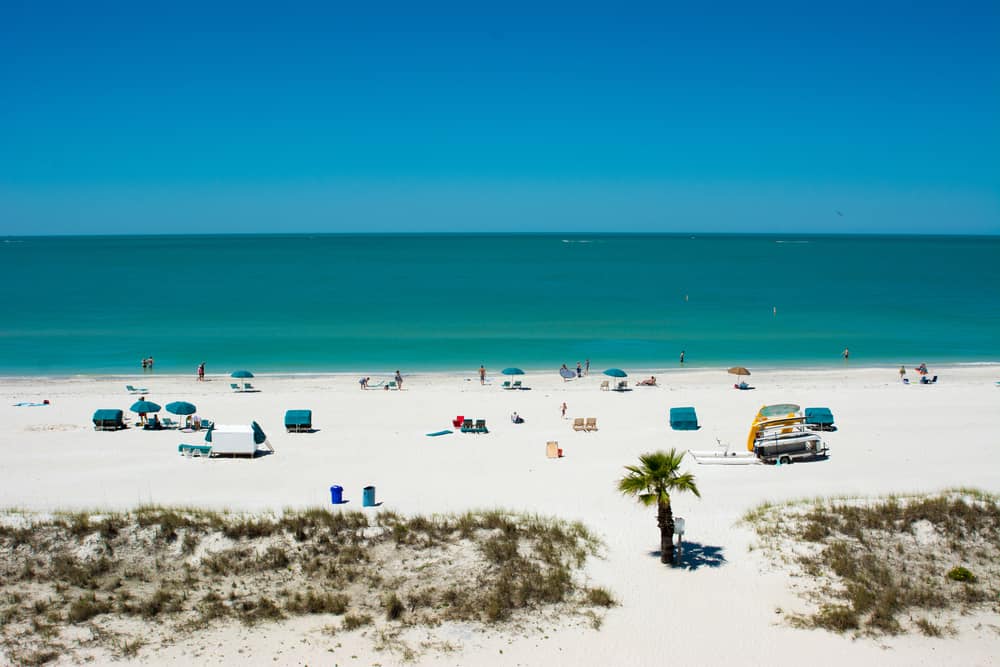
[0,507,615,664]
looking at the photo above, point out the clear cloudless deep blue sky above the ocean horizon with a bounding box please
[0,0,1000,234]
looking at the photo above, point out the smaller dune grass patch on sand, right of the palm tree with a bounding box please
[744,489,1000,637]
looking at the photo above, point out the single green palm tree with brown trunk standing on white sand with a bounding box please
[618,449,701,563]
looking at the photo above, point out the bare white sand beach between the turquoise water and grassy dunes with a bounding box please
[0,368,1000,666]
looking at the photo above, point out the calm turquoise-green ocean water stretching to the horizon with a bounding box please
[0,234,1000,375]
